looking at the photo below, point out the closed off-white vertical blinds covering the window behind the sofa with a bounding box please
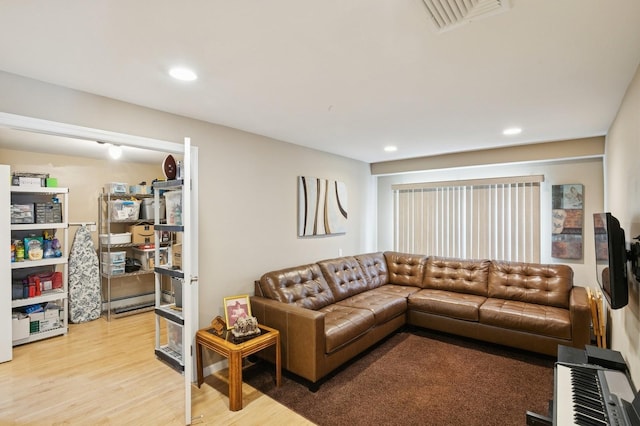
[392,176,544,262]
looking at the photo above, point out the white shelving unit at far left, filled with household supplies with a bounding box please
[10,186,69,346]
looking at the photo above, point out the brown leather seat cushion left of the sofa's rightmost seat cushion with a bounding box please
[409,289,487,322]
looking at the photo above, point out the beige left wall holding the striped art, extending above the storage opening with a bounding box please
[0,72,375,326]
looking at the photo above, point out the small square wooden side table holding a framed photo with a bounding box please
[196,325,282,411]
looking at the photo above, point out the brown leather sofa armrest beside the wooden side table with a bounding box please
[251,296,325,382]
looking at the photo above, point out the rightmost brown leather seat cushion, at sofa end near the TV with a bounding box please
[480,298,571,339]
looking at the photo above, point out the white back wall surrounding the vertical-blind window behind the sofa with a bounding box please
[378,158,603,288]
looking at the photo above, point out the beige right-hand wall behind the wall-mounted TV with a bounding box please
[605,64,640,384]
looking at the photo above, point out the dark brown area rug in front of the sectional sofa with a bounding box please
[243,329,555,426]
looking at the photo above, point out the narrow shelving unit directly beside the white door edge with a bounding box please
[153,180,184,372]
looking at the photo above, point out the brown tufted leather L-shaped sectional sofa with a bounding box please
[251,252,591,383]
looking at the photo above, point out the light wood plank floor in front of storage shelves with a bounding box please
[0,312,312,425]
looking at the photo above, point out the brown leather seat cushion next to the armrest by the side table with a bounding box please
[319,304,375,353]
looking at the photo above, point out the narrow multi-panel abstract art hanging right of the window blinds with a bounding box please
[551,184,584,259]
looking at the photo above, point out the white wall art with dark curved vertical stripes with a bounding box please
[298,176,347,237]
